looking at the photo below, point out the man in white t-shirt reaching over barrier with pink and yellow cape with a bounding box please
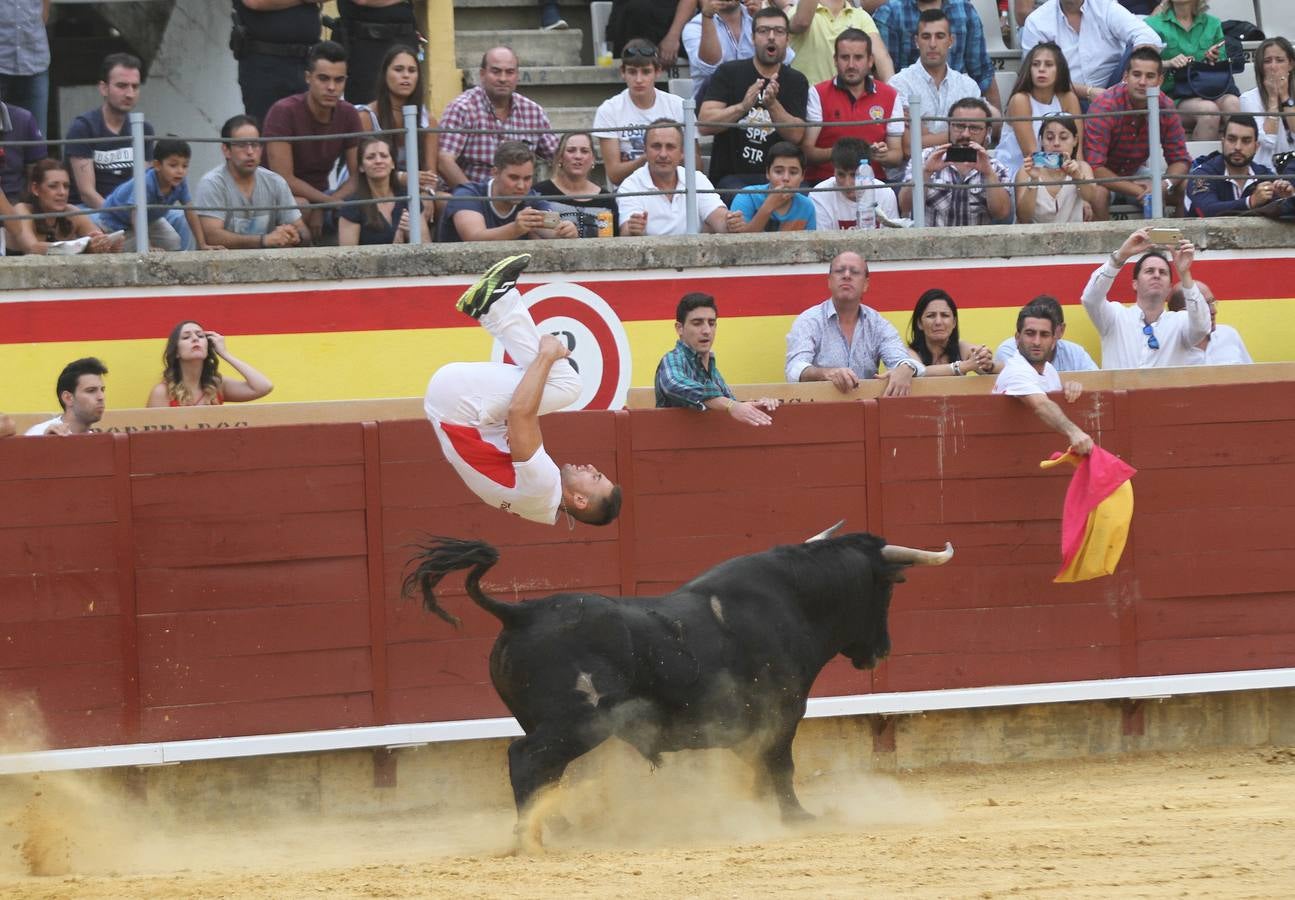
[993,297,1093,456]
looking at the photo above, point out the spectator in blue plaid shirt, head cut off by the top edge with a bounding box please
[873,0,1002,109]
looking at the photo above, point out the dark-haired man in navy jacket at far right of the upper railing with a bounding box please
[1188,113,1292,219]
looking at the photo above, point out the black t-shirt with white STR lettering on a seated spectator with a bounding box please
[702,60,809,184]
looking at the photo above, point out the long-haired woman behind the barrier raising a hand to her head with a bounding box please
[146,321,275,407]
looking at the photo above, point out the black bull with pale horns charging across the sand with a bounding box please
[404,534,952,839]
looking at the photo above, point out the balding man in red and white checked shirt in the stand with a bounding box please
[439,47,558,190]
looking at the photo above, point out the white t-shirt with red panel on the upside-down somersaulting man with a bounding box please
[431,420,562,524]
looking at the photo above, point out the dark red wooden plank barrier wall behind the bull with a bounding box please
[0,385,1295,746]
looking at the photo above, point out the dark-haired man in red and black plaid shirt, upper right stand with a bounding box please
[1084,47,1191,216]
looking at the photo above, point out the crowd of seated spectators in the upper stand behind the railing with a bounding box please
[0,0,1295,254]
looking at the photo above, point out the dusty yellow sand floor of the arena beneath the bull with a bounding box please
[0,748,1295,900]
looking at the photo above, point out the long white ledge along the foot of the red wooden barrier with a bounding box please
[0,668,1295,776]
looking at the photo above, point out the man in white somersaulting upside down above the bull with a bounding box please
[423,254,620,524]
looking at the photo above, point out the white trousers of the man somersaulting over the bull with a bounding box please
[422,287,581,427]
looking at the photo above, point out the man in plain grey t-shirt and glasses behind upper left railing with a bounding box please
[193,115,311,250]
